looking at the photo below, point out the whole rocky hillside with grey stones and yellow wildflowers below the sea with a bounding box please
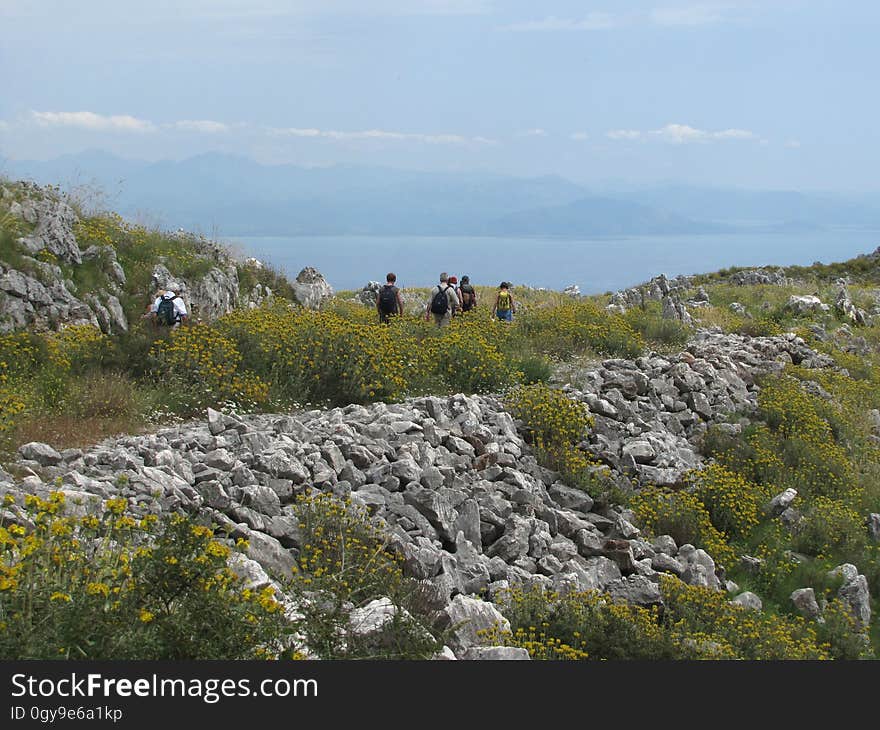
[0,178,880,659]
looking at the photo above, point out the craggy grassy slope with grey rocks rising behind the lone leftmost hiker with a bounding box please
[0,182,332,334]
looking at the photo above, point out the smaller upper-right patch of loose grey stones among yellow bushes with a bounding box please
[564,331,833,485]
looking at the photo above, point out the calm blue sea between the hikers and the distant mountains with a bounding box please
[227,229,880,294]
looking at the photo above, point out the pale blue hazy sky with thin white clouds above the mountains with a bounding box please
[0,0,880,190]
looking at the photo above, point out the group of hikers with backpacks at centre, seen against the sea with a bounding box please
[376,271,516,327]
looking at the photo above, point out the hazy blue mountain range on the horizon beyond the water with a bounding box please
[0,151,880,237]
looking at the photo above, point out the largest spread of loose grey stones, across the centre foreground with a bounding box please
[0,395,717,654]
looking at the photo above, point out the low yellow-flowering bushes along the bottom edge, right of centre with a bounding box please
[485,576,836,660]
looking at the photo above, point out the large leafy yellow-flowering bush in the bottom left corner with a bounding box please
[0,492,296,660]
